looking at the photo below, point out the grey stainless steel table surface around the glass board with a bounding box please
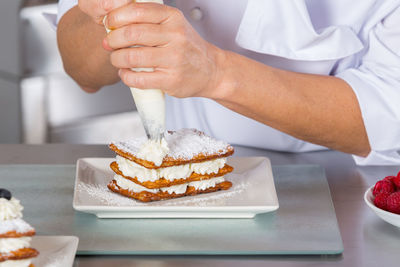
[0,144,400,267]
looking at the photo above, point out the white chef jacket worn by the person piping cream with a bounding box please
[58,0,400,165]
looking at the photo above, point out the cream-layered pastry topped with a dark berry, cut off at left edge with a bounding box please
[0,188,39,267]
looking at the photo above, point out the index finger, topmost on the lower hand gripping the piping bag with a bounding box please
[105,3,178,29]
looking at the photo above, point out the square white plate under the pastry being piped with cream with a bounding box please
[73,157,279,218]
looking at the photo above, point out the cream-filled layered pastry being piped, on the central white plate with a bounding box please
[108,129,234,202]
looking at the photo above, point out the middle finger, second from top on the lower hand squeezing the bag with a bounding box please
[106,24,169,49]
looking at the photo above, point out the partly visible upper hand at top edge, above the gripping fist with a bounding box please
[78,0,132,24]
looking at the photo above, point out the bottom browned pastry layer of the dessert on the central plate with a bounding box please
[108,180,232,202]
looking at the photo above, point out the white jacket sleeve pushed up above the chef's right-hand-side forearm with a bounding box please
[336,7,400,165]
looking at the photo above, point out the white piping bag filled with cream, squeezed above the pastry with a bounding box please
[103,0,165,142]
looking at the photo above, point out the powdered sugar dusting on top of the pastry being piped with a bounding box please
[112,129,233,160]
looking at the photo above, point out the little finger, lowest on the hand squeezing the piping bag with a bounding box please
[119,69,167,89]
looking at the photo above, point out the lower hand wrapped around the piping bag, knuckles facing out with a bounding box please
[104,3,224,98]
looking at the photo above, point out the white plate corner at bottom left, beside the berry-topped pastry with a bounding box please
[31,236,79,267]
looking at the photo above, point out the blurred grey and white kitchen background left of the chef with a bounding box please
[0,0,144,144]
